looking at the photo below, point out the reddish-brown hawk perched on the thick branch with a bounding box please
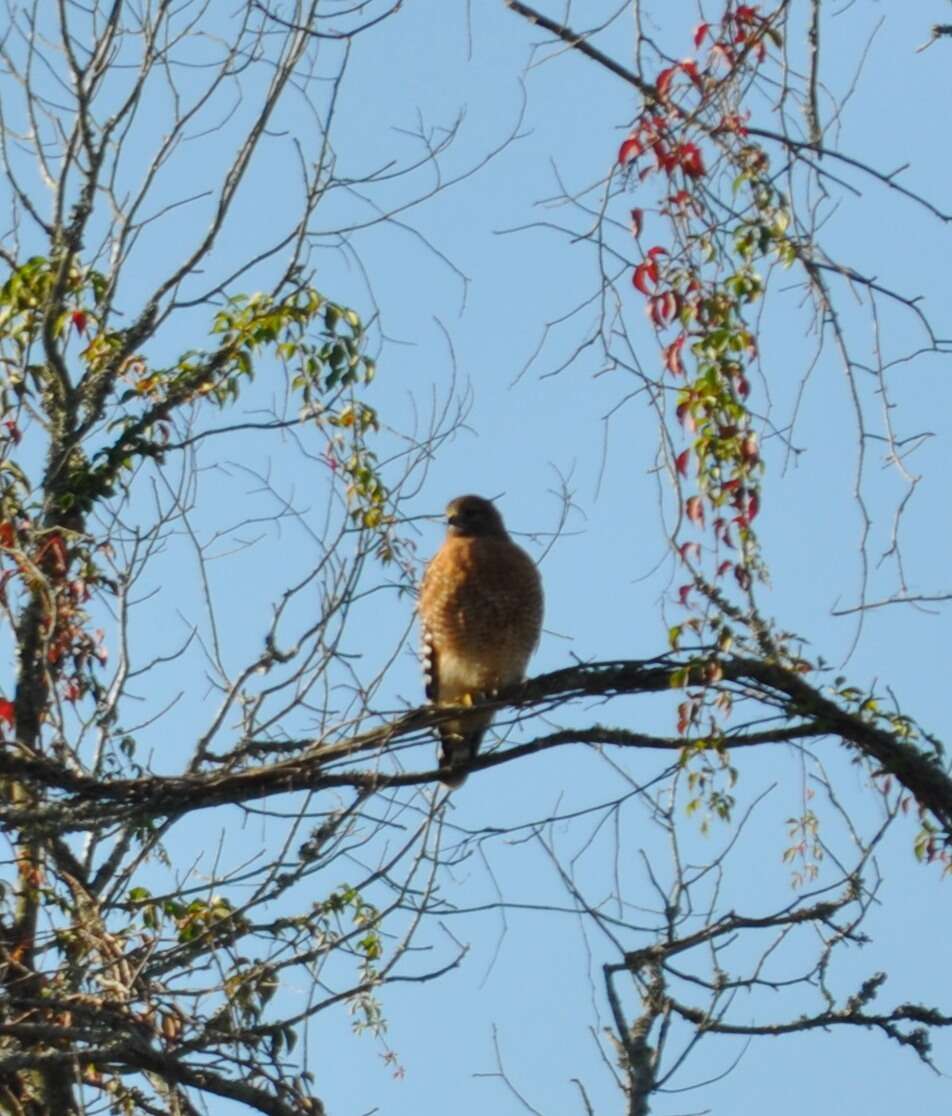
[420,496,542,787]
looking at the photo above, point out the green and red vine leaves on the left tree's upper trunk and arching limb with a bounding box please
[0,257,388,723]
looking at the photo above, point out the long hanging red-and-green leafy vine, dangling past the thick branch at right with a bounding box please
[617,4,797,825]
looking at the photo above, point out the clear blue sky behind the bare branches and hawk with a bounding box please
[1,0,952,1116]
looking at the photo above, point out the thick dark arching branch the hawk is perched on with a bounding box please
[0,656,952,839]
